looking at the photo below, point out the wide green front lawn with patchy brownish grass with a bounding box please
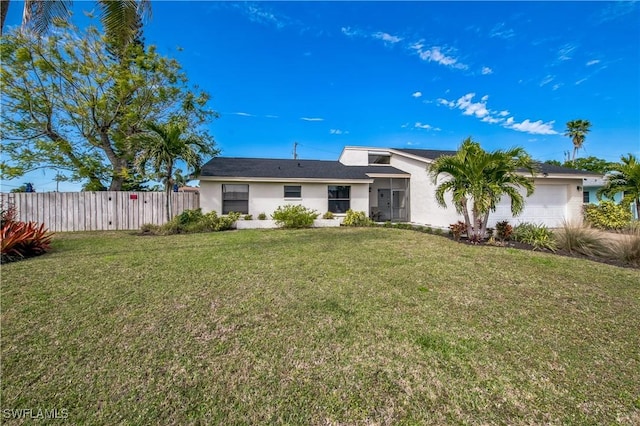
[1,228,640,425]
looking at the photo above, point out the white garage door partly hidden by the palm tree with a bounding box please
[489,185,568,228]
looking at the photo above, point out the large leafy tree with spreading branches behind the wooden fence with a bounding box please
[0,23,217,191]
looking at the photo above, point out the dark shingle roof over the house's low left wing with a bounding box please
[200,157,406,180]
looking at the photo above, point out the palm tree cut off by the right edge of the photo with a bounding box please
[596,154,640,219]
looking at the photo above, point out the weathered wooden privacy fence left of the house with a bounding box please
[0,191,200,232]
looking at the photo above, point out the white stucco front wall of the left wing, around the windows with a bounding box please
[200,180,369,219]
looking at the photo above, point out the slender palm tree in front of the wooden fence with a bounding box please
[136,120,216,221]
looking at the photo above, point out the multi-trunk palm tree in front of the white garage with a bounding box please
[429,138,534,241]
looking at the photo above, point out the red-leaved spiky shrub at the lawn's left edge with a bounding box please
[0,219,53,263]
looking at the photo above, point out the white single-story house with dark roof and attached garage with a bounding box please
[199,147,600,228]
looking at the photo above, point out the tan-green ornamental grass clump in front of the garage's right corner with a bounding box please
[555,222,611,257]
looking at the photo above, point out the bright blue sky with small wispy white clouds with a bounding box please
[3,1,640,191]
